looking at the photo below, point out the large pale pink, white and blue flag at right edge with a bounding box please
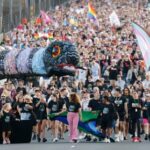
[132,23,150,70]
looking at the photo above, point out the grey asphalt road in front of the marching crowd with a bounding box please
[0,143,150,150]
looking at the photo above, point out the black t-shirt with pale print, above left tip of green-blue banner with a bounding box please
[48,100,61,113]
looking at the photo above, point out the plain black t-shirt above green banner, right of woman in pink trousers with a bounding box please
[88,99,102,111]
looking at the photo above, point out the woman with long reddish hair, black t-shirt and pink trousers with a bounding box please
[67,93,81,142]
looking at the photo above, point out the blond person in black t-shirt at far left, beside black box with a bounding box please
[0,103,12,144]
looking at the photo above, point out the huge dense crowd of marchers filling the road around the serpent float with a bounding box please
[0,0,150,144]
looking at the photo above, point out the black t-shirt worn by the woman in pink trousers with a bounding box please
[67,102,81,112]
